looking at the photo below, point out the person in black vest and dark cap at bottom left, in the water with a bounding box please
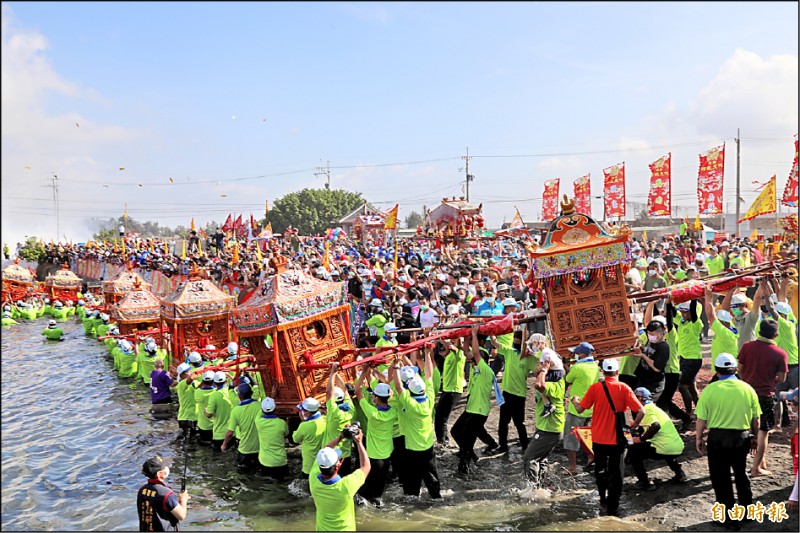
[136,456,189,531]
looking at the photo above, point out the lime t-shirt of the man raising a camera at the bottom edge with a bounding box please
[308,470,366,531]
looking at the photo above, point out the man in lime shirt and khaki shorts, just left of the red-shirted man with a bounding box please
[564,342,600,474]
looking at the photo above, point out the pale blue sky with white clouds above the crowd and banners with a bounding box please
[2,2,798,244]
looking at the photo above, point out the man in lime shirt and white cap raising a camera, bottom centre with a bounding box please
[308,423,371,531]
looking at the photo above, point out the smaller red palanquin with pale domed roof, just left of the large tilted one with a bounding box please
[161,276,234,361]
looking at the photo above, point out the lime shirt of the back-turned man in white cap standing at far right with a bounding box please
[695,377,761,431]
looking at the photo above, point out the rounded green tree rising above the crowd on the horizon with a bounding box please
[263,189,364,235]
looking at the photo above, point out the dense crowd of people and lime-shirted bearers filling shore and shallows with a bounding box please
[4,227,798,530]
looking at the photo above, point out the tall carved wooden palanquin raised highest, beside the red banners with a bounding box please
[529,196,636,359]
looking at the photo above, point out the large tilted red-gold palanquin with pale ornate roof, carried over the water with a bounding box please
[233,257,355,415]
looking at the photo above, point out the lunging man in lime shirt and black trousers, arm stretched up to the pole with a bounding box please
[450,324,502,474]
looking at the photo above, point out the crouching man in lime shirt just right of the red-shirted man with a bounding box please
[628,387,687,491]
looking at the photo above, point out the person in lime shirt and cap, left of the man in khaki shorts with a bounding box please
[522,350,566,488]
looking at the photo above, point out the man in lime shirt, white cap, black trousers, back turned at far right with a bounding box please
[695,353,761,528]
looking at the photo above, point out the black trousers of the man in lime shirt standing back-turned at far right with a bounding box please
[706,429,753,509]
